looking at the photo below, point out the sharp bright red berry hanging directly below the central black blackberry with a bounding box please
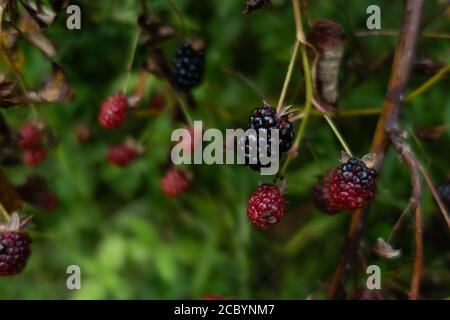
[247,184,287,230]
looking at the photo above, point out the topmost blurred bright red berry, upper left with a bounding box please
[98,93,128,129]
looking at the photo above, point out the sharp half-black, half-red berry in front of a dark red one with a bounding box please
[329,158,377,211]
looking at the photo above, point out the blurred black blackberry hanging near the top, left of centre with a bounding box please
[172,42,205,90]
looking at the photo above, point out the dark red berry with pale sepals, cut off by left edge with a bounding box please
[0,214,32,276]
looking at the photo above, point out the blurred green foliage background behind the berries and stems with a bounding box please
[0,0,450,299]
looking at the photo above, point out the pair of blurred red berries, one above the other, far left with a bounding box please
[17,122,47,167]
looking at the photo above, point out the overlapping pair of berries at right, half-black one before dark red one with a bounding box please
[313,154,377,214]
